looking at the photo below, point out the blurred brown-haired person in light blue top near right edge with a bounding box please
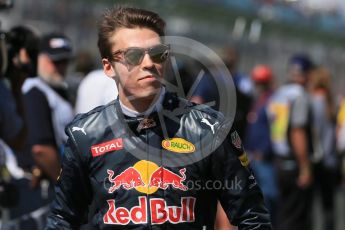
[308,67,338,230]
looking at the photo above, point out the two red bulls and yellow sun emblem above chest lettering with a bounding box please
[107,160,188,194]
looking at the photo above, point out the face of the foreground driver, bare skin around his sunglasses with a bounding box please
[102,28,164,100]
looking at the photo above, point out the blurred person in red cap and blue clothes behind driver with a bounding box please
[244,65,278,227]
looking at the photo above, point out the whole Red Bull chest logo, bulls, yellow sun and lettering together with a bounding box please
[103,160,196,225]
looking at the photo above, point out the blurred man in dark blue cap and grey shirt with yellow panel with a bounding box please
[267,54,313,230]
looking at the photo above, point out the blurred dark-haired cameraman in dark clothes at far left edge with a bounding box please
[0,26,49,229]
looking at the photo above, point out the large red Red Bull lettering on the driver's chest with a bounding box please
[103,196,196,225]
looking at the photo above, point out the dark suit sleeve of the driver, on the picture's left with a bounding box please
[45,132,91,229]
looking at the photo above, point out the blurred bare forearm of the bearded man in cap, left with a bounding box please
[31,145,61,182]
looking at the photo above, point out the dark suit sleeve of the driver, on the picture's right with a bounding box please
[211,126,272,230]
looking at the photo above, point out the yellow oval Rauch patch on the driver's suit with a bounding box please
[162,137,195,153]
